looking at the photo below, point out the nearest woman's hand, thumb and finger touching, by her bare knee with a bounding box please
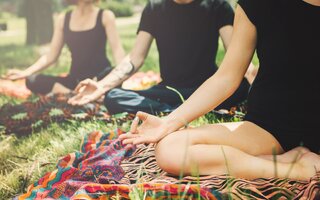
[119,112,174,145]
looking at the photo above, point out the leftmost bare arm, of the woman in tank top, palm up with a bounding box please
[6,14,65,80]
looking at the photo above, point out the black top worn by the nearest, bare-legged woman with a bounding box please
[239,0,320,132]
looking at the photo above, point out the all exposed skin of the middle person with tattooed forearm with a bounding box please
[69,0,256,105]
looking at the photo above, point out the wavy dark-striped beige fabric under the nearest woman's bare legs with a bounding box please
[121,145,320,200]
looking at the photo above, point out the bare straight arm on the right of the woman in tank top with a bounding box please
[102,11,125,65]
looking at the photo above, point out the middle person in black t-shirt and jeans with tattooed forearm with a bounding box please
[70,0,255,114]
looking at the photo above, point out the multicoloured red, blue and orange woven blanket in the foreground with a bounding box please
[18,130,219,200]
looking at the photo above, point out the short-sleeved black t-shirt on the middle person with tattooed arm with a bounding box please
[138,0,234,87]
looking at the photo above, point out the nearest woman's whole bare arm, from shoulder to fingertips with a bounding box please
[120,6,257,144]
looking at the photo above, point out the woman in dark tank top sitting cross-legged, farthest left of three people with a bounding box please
[5,0,125,95]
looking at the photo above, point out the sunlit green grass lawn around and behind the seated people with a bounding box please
[0,15,256,199]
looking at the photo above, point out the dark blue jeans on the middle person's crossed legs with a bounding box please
[104,79,250,114]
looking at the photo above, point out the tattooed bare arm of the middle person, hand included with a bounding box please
[69,31,153,105]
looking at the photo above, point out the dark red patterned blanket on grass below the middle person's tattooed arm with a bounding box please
[0,94,133,136]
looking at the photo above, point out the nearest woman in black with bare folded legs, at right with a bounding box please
[120,0,320,180]
